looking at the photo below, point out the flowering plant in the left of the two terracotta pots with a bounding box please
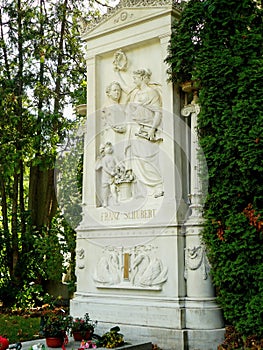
[40,308,72,338]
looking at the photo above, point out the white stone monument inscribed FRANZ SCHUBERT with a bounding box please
[71,0,224,350]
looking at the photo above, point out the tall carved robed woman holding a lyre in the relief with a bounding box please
[126,69,164,198]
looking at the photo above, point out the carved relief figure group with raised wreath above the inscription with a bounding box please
[96,50,164,207]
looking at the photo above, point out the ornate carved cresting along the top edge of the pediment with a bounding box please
[81,0,183,33]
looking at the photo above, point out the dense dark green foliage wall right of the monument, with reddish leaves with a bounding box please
[168,0,263,337]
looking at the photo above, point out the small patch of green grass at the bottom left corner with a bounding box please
[0,314,40,344]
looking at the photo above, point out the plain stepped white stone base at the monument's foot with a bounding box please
[70,293,225,350]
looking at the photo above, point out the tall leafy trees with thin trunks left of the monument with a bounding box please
[0,0,101,306]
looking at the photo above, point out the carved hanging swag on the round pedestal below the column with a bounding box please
[184,245,211,280]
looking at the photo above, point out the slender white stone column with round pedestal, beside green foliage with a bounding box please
[184,91,224,348]
